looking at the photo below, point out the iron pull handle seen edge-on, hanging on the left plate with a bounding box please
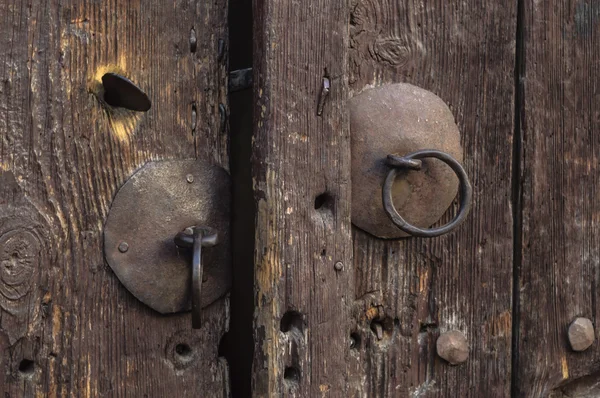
[175,227,219,329]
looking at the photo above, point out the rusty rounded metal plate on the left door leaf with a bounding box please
[104,160,231,314]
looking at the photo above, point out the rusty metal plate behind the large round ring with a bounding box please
[349,83,463,239]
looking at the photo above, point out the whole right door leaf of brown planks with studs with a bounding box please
[253,0,600,397]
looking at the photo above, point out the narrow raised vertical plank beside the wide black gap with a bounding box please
[253,0,353,397]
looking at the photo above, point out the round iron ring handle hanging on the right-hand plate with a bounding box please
[382,149,473,238]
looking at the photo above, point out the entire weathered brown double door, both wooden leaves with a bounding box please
[0,0,600,398]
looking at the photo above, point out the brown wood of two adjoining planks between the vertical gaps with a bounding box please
[254,0,517,397]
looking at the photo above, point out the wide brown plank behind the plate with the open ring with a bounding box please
[348,0,517,397]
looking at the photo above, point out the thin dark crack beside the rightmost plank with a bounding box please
[511,0,525,398]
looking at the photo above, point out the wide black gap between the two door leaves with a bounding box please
[219,0,255,398]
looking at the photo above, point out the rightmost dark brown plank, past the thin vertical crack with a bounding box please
[515,0,600,397]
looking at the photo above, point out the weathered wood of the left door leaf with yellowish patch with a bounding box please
[0,0,228,397]
